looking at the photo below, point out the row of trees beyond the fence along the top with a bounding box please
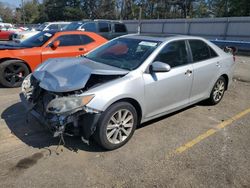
[0,0,250,23]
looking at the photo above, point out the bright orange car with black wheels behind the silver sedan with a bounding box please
[0,31,107,87]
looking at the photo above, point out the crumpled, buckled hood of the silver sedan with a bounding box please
[33,58,128,92]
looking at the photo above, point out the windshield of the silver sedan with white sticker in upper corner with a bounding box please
[85,38,160,70]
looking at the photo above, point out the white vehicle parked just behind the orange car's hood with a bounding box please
[13,22,70,43]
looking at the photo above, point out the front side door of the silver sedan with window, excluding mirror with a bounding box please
[143,40,193,118]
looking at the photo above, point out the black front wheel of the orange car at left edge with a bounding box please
[0,60,30,88]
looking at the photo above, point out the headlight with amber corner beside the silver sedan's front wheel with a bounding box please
[47,95,94,114]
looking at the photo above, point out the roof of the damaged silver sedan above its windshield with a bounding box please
[122,33,206,42]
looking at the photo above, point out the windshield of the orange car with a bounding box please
[20,32,54,47]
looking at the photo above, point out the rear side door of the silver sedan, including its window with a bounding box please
[188,40,220,102]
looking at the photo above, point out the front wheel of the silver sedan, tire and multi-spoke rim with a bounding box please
[95,102,138,150]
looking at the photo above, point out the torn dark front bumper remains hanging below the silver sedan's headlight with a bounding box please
[20,93,101,142]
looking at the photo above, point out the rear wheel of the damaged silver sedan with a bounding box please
[208,76,227,105]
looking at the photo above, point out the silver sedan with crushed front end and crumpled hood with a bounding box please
[20,34,234,150]
